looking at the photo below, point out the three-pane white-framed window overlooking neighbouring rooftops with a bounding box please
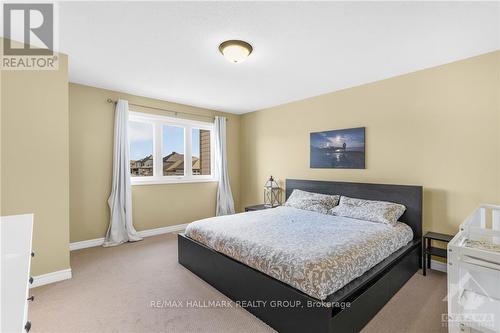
[129,112,214,185]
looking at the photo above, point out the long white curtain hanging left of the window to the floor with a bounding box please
[103,99,142,246]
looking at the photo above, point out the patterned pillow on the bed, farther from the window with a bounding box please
[329,196,406,225]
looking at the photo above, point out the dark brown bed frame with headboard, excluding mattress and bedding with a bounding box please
[178,179,422,333]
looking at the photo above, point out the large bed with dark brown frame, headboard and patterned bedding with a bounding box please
[178,179,422,332]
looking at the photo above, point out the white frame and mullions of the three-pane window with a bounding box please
[129,111,216,185]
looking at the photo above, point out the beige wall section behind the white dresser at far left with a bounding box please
[0,53,69,275]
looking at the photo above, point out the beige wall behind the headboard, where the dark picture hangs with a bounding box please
[240,52,500,233]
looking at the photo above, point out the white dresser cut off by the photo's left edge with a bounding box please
[0,214,34,333]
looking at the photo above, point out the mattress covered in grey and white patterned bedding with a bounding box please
[186,207,413,300]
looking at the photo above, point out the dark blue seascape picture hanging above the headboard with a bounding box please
[310,127,365,169]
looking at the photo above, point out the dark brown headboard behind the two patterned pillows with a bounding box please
[286,179,422,239]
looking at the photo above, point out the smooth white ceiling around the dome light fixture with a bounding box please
[59,2,500,113]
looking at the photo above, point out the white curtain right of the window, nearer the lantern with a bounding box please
[214,117,234,216]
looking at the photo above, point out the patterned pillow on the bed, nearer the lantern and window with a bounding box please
[285,190,340,214]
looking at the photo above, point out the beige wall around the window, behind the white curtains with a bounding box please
[69,83,240,242]
